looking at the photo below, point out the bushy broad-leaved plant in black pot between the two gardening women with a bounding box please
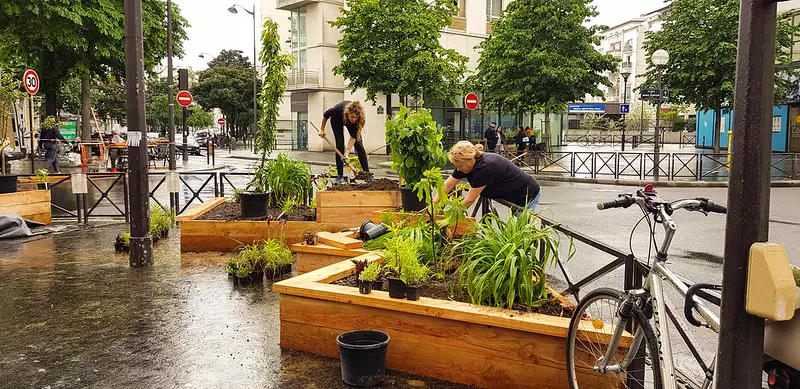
[386,104,447,211]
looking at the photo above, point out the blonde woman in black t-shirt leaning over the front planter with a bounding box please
[444,141,542,210]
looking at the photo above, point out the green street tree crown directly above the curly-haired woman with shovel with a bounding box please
[330,0,467,102]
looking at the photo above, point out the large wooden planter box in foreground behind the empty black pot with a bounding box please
[272,253,631,389]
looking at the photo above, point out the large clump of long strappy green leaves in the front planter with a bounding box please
[457,210,574,308]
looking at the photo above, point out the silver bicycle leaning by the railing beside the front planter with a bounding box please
[567,185,727,389]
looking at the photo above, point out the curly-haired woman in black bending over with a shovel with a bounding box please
[319,100,369,184]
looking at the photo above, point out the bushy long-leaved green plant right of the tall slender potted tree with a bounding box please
[266,153,311,206]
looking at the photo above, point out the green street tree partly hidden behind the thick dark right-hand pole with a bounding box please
[645,0,798,153]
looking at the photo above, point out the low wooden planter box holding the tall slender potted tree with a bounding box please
[176,198,353,252]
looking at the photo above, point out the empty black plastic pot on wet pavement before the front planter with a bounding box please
[336,330,391,387]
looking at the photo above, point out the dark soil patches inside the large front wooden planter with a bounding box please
[332,273,574,318]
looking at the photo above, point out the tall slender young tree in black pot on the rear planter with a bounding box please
[239,18,292,217]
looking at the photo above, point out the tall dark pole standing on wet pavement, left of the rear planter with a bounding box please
[125,0,153,267]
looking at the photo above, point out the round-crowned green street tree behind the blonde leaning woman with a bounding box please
[472,0,618,148]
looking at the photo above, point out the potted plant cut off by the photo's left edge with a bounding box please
[0,68,24,193]
